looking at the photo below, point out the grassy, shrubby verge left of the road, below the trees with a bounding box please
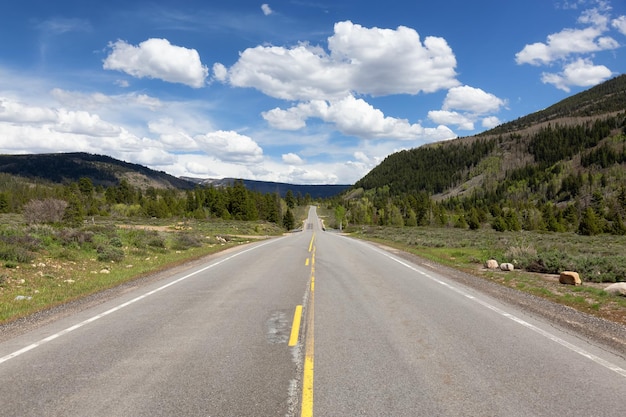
[0,216,282,323]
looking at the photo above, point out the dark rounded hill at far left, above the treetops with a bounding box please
[0,152,195,190]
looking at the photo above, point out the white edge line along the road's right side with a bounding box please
[358,237,626,378]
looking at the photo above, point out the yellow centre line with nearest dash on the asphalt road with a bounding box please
[289,233,315,417]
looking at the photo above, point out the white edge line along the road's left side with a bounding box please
[0,239,280,365]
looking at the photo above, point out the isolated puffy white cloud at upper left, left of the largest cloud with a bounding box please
[103,38,208,88]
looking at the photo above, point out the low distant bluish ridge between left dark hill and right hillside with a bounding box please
[182,177,351,199]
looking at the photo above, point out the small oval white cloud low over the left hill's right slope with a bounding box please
[194,130,263,164]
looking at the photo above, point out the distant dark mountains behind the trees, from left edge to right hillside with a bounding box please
[0,152,350,198]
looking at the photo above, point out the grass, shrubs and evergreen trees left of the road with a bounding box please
[0,174,310,323]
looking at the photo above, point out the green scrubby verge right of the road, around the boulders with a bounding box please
[351,227,626,324]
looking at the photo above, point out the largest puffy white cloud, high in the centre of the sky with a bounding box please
[213,21,458,101]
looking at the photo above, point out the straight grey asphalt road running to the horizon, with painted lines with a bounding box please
[0,209,626,417]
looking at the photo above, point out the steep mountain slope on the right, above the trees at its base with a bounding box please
[348,75,626,204]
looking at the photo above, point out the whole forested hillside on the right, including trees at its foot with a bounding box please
[338,75,626,234]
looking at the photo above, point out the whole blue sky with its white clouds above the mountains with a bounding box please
[0,0,626,184]
